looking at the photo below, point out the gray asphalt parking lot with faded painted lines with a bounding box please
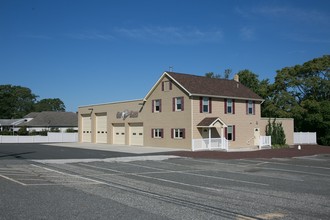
[0,145,330,220]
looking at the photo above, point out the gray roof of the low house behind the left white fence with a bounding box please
[20,111,78,127]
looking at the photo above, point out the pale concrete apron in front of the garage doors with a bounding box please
[45,143,189,154]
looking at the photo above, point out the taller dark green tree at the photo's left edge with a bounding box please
[0,85,37,119]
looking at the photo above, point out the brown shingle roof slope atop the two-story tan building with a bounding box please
[166,72,263,101]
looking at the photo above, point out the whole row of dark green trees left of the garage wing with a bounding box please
[0,84,65,119]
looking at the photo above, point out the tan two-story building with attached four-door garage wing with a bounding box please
[78,72,293,149]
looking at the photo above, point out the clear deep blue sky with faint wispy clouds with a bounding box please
[0,0,330,111]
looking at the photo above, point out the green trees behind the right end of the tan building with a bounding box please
[205,55,330,145]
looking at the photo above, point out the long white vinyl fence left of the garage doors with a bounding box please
[0,132,78,143]
